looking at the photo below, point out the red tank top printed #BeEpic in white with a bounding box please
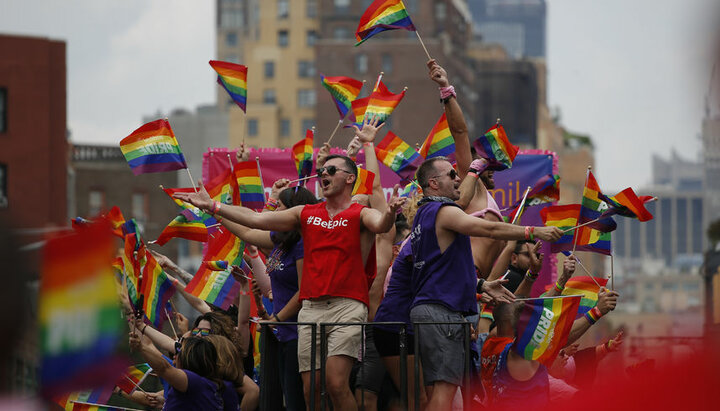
[300,202,376,305]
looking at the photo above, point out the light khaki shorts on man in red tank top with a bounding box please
[298,297,367,372]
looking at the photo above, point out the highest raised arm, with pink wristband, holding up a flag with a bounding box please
[427,60,472,178]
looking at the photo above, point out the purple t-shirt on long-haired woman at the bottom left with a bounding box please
[163,370,226,411]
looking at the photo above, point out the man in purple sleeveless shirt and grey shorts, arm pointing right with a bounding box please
[410,157,562,410]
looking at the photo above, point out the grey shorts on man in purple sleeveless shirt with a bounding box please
[410,304,466,386]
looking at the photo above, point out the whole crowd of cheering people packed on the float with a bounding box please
[105,60,623,410]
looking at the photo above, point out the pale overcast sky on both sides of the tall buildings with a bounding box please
[0,0,713,193]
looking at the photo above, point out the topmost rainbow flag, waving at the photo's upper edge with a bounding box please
[355,0,415,46]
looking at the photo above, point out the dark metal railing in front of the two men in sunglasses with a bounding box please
[260,321,472,411]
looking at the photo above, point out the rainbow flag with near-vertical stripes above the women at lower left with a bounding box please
[139,247,175,327]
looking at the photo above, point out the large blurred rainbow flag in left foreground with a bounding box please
[38,222,126,398]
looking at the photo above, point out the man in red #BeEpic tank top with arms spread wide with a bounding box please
[176,155,405,410]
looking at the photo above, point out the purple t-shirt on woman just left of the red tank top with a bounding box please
[265,237,303,342]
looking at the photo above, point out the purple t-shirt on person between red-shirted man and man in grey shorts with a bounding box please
[373,241,413,333]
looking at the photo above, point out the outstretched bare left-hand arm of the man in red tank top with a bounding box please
[173,182,303,231]
